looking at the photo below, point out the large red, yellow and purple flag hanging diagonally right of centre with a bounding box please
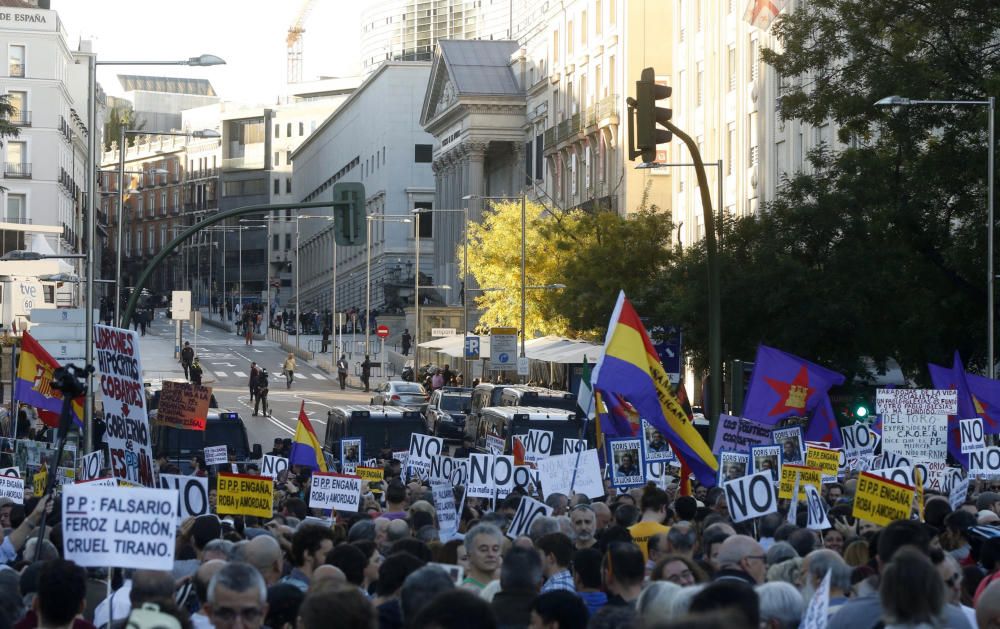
[592,291,719,486]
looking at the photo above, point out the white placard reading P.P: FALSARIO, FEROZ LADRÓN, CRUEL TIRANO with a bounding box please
[62,483,177,572]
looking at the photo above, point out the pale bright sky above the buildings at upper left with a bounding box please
[52,0,370,104]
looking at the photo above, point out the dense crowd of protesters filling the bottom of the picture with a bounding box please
[0,440,1000,629]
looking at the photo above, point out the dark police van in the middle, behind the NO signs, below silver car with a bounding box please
[323,404,427,461]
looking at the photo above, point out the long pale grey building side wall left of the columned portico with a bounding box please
[292,61,441,324]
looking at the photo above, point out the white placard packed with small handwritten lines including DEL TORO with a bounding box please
[875,389,958,461]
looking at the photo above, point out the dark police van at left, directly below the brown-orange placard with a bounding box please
[150,408,264,474]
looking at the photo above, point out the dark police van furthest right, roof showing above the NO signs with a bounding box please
[465,406,594,456]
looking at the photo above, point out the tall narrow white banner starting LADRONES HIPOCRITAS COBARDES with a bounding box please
[94,325,154,487]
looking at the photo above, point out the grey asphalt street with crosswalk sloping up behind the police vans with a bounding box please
[140,317,378,452]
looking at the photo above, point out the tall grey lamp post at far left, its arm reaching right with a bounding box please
[83,53,225,454]
